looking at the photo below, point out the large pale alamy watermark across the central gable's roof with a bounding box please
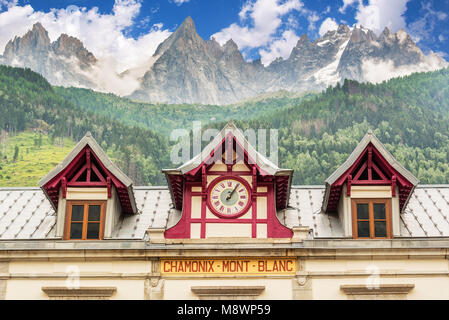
[170,121,279,166]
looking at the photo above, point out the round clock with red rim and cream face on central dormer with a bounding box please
[207,176,251,218]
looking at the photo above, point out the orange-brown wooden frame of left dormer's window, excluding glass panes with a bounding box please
[63,200,106,241]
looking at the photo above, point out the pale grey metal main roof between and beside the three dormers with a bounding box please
[0,185,449,240]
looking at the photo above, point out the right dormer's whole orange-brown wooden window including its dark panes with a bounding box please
[352,199,391,239]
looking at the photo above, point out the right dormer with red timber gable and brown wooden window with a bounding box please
[322,132,418,239]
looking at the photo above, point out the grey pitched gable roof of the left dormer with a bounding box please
[38,132,137,213]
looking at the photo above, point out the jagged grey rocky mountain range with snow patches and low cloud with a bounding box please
[0,17,448,104]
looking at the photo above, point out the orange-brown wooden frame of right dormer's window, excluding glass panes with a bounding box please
[351,198,393,239]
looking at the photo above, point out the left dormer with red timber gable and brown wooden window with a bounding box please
[39,133,137,240]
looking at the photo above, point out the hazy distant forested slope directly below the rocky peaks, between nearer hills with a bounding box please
[54,87,313,136]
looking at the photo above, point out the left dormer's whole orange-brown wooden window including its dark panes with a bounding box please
[64,201,106,240]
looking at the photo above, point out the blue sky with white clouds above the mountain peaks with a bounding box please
[0,0,449,72]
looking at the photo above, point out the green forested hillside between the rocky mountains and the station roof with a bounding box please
[0,66,449,186]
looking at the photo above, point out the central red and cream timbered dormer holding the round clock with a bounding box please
[163,122,293,238]
